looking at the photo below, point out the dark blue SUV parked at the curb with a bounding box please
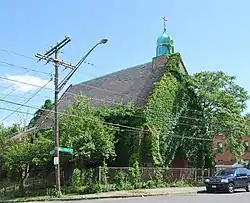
[205,168,250,193]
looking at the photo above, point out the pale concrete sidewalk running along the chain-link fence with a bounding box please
[3,187,204,202]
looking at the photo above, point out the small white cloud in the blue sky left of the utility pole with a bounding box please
[2,75,53,92]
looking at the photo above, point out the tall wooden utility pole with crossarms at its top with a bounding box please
[35,37,75,194]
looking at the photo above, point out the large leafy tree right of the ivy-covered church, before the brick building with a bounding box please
[191,71,249,159]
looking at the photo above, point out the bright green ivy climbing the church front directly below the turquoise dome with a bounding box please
[145,54,192,166]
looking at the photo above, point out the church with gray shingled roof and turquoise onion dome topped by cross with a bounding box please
[11,17,240,168]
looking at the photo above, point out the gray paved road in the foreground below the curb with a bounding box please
[43,192,250,203]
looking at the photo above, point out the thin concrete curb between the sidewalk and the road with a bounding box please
[0,191,204,202]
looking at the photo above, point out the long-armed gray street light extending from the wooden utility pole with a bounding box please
[58,38,108,92]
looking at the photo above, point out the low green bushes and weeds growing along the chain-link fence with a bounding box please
[0,166,213,197]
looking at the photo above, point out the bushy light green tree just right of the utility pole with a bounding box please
[60,97,115,168]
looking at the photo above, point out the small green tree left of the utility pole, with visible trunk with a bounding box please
[2,133,53,191]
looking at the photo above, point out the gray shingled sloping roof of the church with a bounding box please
[12,56,186,133]
